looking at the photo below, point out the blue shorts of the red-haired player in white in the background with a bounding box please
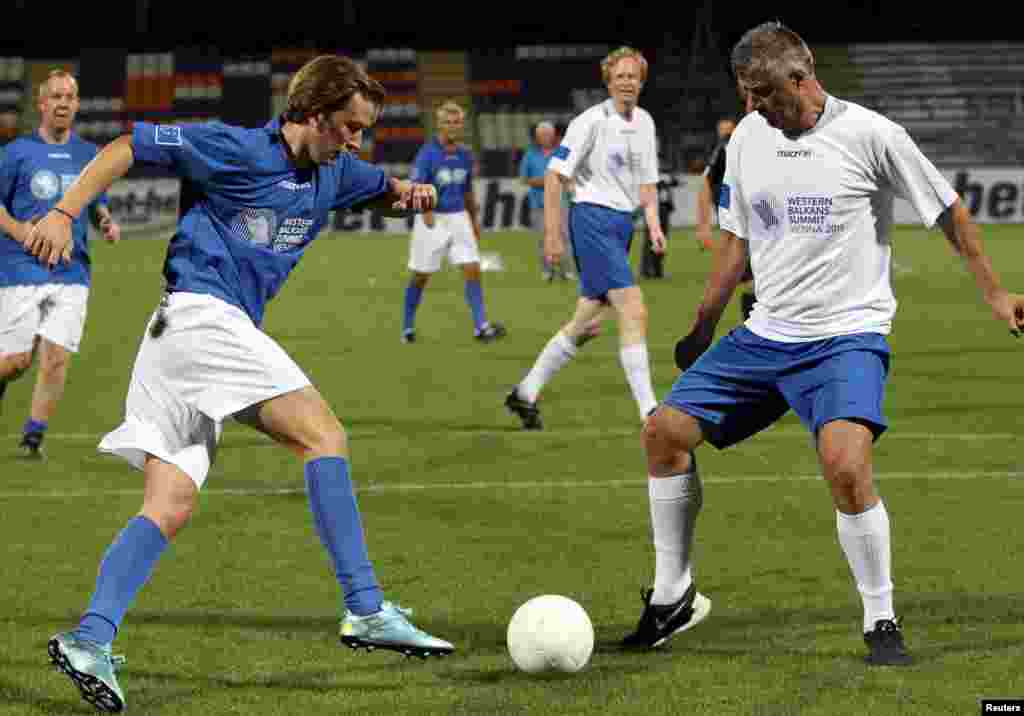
[569,204,636,300]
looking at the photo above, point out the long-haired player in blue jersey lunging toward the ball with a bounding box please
[27,55,454,711]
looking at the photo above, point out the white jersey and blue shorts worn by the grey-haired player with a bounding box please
[666,96,956,448]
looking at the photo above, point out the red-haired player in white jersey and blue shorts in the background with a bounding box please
[505,47,665,430]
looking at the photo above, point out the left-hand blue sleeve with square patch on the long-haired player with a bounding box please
[132,122,242,183]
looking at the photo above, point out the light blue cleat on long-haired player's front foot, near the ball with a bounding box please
[339,601,455,659]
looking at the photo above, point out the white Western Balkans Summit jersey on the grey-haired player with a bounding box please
[719,96,956,342]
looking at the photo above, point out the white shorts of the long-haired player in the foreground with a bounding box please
[99,293,310,488]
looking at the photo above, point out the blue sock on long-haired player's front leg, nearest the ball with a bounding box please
[305,458,384,617]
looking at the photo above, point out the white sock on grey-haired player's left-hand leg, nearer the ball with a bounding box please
[647,471,703,604]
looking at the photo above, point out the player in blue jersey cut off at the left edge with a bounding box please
[0,70,121,459]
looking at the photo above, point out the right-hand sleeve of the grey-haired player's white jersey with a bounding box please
[879,125,957,227]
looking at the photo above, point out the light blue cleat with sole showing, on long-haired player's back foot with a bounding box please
[47,631,125,714]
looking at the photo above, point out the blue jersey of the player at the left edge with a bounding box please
[0,132,106,286]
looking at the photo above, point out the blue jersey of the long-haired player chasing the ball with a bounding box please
[132,120,390,325]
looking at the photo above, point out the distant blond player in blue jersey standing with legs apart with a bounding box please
[401,101,505,343]
